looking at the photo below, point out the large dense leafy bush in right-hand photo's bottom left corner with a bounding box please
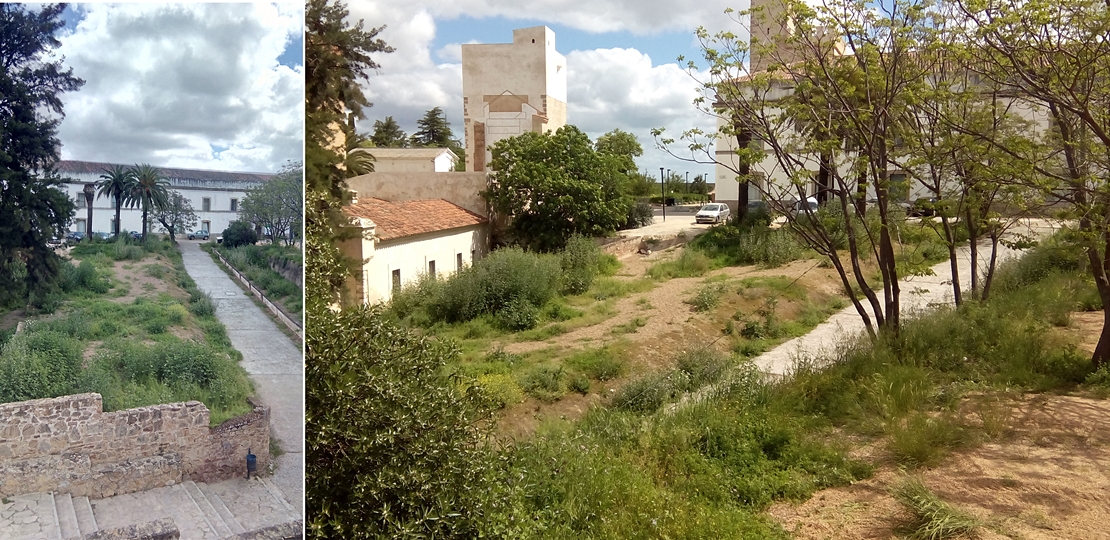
[305,306,495,538]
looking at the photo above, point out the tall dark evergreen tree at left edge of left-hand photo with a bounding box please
[0,3,84,306]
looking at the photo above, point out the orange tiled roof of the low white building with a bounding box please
[343,198,487,240]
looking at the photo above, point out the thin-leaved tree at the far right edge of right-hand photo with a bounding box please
[955,0,1110,368]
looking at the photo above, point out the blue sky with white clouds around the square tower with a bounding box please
[349,0,747,183]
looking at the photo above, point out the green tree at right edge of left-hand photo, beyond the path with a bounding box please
[239,163,304,246]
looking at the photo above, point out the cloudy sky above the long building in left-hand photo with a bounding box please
[58,2,304,172]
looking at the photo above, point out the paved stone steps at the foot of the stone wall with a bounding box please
[0,477,303,540]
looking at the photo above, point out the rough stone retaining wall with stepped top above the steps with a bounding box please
[0,393,270,498]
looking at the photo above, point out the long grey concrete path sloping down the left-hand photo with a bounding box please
[179,240,304,517]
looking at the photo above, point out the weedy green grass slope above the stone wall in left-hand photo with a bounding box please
[0,238,253,424]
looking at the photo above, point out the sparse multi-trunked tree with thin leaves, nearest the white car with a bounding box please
[656,0,937,338]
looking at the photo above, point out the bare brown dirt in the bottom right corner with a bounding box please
[767,312,1110,540]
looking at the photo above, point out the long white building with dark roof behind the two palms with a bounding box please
[57,160,274,234]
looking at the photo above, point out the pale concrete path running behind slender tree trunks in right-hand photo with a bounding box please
[753,220,1059,376]
